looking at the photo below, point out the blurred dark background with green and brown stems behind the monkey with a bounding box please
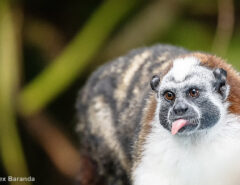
[0,0,240,185]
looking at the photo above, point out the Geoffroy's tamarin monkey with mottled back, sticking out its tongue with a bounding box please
[77,45,240,185]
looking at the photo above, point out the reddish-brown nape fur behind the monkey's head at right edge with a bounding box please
[192,53,240,114]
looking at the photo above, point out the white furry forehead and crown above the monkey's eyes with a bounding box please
[161,57,214,89]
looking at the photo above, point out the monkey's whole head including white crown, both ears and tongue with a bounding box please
[151,57,229,135]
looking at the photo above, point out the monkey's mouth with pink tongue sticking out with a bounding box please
[171,118,199,135]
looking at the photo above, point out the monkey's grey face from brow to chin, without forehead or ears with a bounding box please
[159,84,220,134]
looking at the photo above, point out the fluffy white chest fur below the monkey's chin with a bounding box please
[133,115,240,185]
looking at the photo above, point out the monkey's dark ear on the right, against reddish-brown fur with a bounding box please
[213,68,229,100]
